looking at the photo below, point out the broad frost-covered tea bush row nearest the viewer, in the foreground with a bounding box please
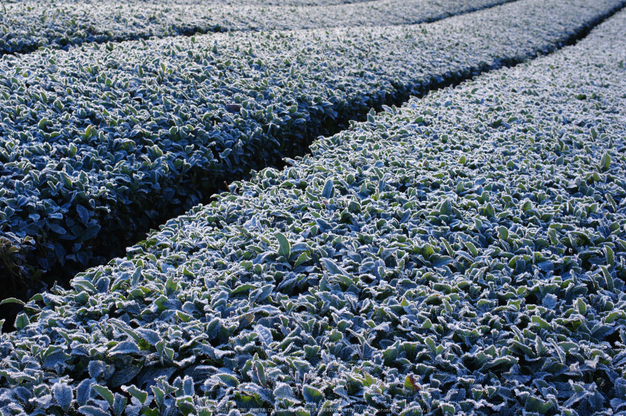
[0,3,626,415]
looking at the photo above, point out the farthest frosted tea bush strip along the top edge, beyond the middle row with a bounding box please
[0,0,511,54]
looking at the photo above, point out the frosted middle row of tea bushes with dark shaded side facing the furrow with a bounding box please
[0,0,625,298]
